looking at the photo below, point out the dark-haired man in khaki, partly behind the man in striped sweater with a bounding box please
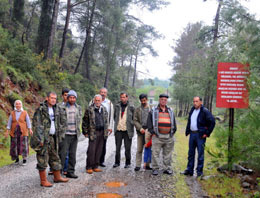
[134,94,150,171]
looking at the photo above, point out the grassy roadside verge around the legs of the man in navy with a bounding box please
[171,119,248,198]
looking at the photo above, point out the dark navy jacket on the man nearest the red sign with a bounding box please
[186,106,215,137]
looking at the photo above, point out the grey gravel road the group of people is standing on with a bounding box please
[0,132,207,198]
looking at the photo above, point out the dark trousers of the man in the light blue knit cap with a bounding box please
[60,135,78,173]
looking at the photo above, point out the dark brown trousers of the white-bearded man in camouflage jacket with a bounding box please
[86,130,104,169]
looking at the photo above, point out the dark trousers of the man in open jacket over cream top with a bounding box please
[115,131,132,165]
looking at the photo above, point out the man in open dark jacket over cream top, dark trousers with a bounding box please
[113,93,135,168]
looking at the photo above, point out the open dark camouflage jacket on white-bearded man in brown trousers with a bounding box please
[82,104,108,141]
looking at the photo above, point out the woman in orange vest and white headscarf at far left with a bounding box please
[5,100,33,165]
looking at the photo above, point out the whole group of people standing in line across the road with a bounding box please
[6,88,215,187]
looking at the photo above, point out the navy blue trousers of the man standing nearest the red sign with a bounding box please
[187,132,206,174]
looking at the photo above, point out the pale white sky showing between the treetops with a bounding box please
[130,0,260,80]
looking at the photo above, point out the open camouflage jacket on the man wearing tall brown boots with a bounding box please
[30,101,67,152]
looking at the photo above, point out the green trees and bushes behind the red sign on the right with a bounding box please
[170,0,260,170]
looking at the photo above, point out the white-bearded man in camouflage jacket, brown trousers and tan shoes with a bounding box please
[82,95,108,174]
